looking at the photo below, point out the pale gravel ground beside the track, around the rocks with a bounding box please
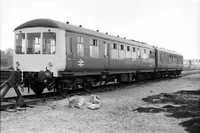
[1,74,200,133]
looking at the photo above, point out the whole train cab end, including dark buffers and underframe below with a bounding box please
[13,26,66,96]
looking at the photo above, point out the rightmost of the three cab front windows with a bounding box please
[42,32,56,54]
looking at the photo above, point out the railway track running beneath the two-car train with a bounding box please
[0,71,199,111]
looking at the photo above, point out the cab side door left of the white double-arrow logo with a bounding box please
[65,32,75,70]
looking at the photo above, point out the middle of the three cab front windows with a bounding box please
[26,33,41,54]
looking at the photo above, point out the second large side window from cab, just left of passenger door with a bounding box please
[90,38,100,58]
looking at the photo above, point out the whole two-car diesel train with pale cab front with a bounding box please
[13,19,183,95]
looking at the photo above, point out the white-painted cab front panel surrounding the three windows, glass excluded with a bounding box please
[13,28,66,76]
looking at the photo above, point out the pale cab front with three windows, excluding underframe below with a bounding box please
[13,27,65,76]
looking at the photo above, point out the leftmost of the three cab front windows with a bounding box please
[15,33,26,54]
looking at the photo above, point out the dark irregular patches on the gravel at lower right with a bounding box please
[134,90,200,133]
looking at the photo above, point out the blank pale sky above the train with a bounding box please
[0,0,200,59]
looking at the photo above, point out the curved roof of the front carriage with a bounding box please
[14,19,153,49]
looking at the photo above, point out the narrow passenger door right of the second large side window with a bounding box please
[104,43,110,70]
